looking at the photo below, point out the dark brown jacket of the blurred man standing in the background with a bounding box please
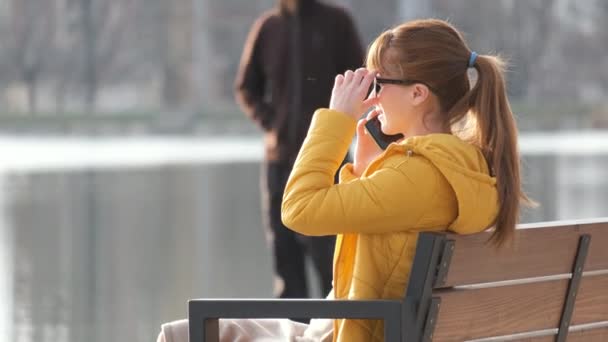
[235,0,364,162]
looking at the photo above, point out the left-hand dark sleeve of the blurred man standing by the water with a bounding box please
[234,17,274,131]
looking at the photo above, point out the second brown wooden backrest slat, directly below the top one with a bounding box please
[433,275,608,341]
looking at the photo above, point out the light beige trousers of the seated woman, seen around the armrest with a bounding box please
[157,319,333,342]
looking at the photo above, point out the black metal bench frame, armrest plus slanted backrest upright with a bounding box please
[188,233,453,342]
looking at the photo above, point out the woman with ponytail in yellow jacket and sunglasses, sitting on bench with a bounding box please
[161,19,528,342]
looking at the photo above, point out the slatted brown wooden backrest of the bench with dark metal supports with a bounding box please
[406,219,608,342]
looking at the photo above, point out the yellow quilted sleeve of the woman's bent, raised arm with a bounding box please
[281,110,439,236]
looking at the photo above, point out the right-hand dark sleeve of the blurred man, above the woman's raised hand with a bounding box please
[336,11,365,74]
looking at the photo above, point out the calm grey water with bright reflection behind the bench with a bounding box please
[0,132,608,342]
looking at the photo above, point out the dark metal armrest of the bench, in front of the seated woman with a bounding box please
[188,299,402,342]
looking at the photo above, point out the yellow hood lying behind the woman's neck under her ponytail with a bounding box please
[387,134,499,234]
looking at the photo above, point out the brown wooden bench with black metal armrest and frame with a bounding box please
[189,218,608,342]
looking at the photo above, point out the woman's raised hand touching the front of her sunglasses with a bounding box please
[329,68,377,120]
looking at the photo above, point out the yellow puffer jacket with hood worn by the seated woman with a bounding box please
[282,109,498,342]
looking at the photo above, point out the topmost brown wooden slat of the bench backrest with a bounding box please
[441,223,608,287]
